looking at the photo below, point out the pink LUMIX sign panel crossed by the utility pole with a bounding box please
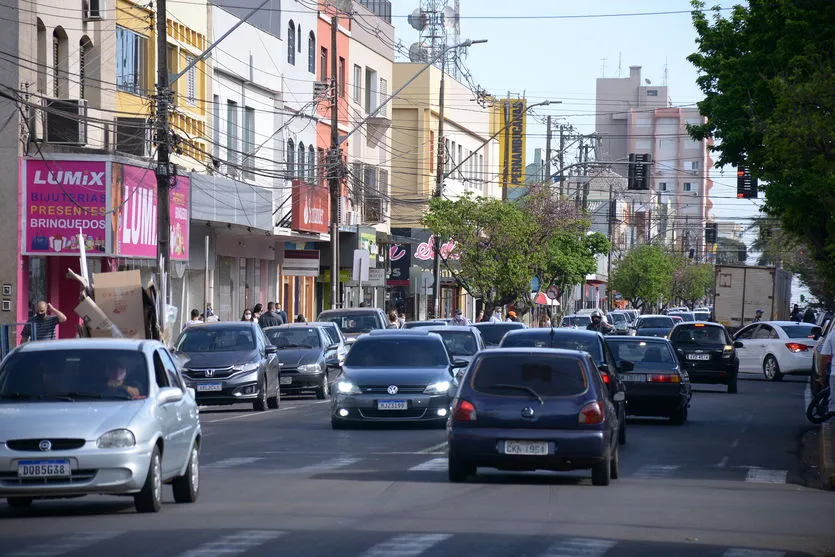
[111,163,190,261]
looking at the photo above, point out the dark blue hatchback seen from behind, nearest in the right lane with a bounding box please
[447,348,624,485]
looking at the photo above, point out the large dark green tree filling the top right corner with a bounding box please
[688,0,835,296]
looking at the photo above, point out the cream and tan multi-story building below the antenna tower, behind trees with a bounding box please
[388,63,501,315]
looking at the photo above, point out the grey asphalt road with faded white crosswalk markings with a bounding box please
[0,378,835,557]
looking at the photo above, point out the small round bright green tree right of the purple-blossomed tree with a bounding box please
[610,244,675,310]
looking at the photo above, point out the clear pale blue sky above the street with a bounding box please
[392,0,760,226]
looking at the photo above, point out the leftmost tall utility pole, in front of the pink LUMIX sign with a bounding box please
[156,0,171,332]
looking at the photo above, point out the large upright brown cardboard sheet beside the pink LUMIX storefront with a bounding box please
[93,271,145,339]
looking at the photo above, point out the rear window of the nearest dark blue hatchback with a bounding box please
[473,354,588,398]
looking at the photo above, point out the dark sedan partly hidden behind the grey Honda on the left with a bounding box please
[264,323,338,400]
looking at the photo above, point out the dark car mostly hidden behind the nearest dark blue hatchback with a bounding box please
[499,328,632,444]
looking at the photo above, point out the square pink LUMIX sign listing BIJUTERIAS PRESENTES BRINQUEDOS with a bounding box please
[21,160,107,255]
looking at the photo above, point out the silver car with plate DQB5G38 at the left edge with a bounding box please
[0,339,201,512]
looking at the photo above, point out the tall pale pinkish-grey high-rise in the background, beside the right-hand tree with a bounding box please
[595,66,713,260]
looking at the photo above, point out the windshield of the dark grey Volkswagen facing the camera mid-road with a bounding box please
[345,333,449,369]
